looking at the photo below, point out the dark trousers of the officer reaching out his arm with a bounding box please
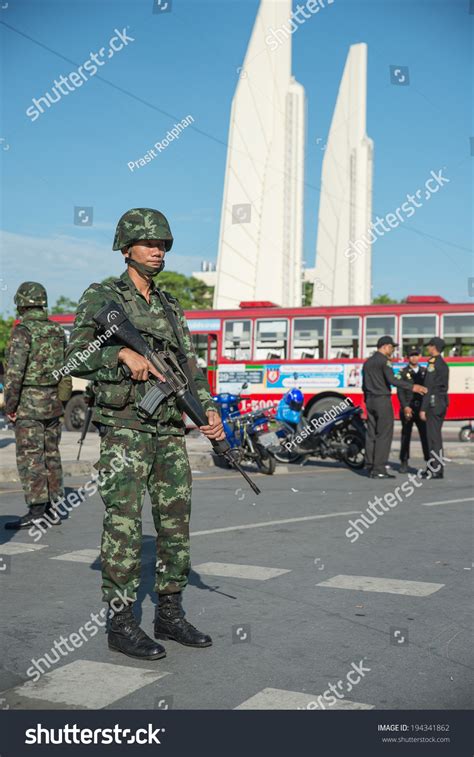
[365,395,393,473]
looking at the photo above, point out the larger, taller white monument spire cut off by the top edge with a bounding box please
[214,0,305,308]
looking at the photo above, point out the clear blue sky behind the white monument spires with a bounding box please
[0,0,474,313]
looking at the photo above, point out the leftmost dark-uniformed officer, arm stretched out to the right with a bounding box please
[362,336,426,478]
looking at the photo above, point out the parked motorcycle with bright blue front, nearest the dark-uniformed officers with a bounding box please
[260,389,365,470]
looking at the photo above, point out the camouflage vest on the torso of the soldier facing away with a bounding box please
[21,318,65,386]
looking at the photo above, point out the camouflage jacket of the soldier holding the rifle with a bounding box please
[67,271,215,436]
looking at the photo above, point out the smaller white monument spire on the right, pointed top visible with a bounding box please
[313,43,373,305]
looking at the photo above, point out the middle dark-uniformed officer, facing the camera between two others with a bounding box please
[397,347,430,473]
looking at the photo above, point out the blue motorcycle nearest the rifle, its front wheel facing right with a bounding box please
[213,383,276,476]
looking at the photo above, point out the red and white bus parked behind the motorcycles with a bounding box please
[52,296,474,428]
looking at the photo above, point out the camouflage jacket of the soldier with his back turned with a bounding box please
[5,308,66,420]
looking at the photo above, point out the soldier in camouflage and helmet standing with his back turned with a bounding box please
[5,281,66,529]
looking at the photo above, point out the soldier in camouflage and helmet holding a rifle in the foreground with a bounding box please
[68,208,224,660]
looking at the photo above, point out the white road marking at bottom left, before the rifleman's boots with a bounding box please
[4,650,170,710]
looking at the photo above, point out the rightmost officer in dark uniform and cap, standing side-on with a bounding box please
[420,336,449,478]
